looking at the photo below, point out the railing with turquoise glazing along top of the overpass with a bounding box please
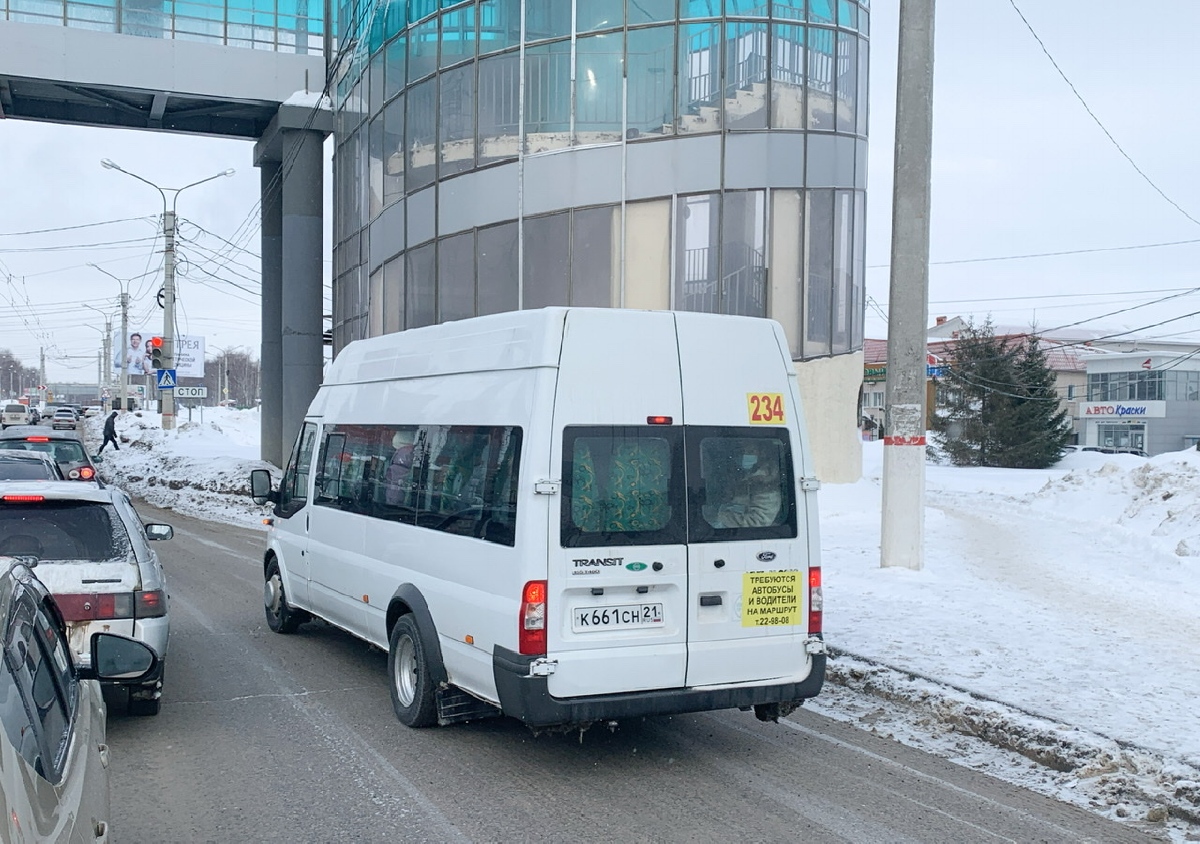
[0,0,325,55]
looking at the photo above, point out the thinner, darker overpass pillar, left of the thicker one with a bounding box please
[259,161,283,468]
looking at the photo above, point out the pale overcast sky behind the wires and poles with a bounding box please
[0,0,1200,387]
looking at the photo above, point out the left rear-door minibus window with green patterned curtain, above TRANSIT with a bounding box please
[559,426,685,547]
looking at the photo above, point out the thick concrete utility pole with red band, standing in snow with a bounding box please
[880,0,934,569]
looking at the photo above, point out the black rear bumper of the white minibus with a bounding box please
[492,646,826,726]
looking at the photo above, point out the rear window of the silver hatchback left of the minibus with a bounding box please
[0,501,131,563]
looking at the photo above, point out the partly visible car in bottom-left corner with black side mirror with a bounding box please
[0,557,157,842]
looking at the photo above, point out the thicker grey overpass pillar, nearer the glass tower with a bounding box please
[281,128,324,458]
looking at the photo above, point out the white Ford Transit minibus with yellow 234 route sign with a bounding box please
[251,307,826,729]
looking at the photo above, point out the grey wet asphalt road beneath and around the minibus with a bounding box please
[108,504,1150,844]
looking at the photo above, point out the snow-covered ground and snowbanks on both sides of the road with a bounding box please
[88,408,1200,842]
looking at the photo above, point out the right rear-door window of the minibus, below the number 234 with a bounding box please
[688,427,796,541]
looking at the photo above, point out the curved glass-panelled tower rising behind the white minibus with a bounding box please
[332,0,870,360]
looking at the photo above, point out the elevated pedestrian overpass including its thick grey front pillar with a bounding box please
[0,0,332,465]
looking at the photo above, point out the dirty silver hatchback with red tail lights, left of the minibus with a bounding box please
[0,480,174,716]
